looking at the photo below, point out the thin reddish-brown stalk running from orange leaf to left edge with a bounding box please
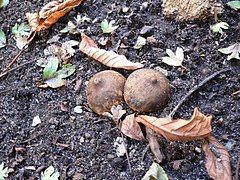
[0,31,37,78]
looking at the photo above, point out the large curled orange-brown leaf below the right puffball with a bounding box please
[136,108,212,141]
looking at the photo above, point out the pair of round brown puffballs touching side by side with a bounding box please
[87,69,171,114]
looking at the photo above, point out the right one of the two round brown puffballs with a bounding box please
[124,69,171,112]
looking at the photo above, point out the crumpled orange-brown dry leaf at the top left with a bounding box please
[26,0,82,31]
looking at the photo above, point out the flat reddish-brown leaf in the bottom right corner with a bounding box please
[202,135,232,180]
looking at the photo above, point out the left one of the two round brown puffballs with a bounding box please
[86,70,126,115]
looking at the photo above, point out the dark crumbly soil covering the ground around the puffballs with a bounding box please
[0,0,240,179]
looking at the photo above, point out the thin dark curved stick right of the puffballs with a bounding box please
[169,68,231,119]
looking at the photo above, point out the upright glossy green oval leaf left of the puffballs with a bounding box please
[43,56,58,79]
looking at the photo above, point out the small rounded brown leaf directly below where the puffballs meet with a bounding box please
[121,114,145,141]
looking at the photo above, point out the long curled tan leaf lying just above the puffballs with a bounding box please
[79,33,143,69]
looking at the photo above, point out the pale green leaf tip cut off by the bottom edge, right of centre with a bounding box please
[142,162,168,180]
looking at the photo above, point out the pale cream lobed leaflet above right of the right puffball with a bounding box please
[162,47,184,66]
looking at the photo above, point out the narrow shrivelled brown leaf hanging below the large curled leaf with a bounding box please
[146,127,163,163]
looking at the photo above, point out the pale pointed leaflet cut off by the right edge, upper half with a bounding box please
[218,43,240,60]
